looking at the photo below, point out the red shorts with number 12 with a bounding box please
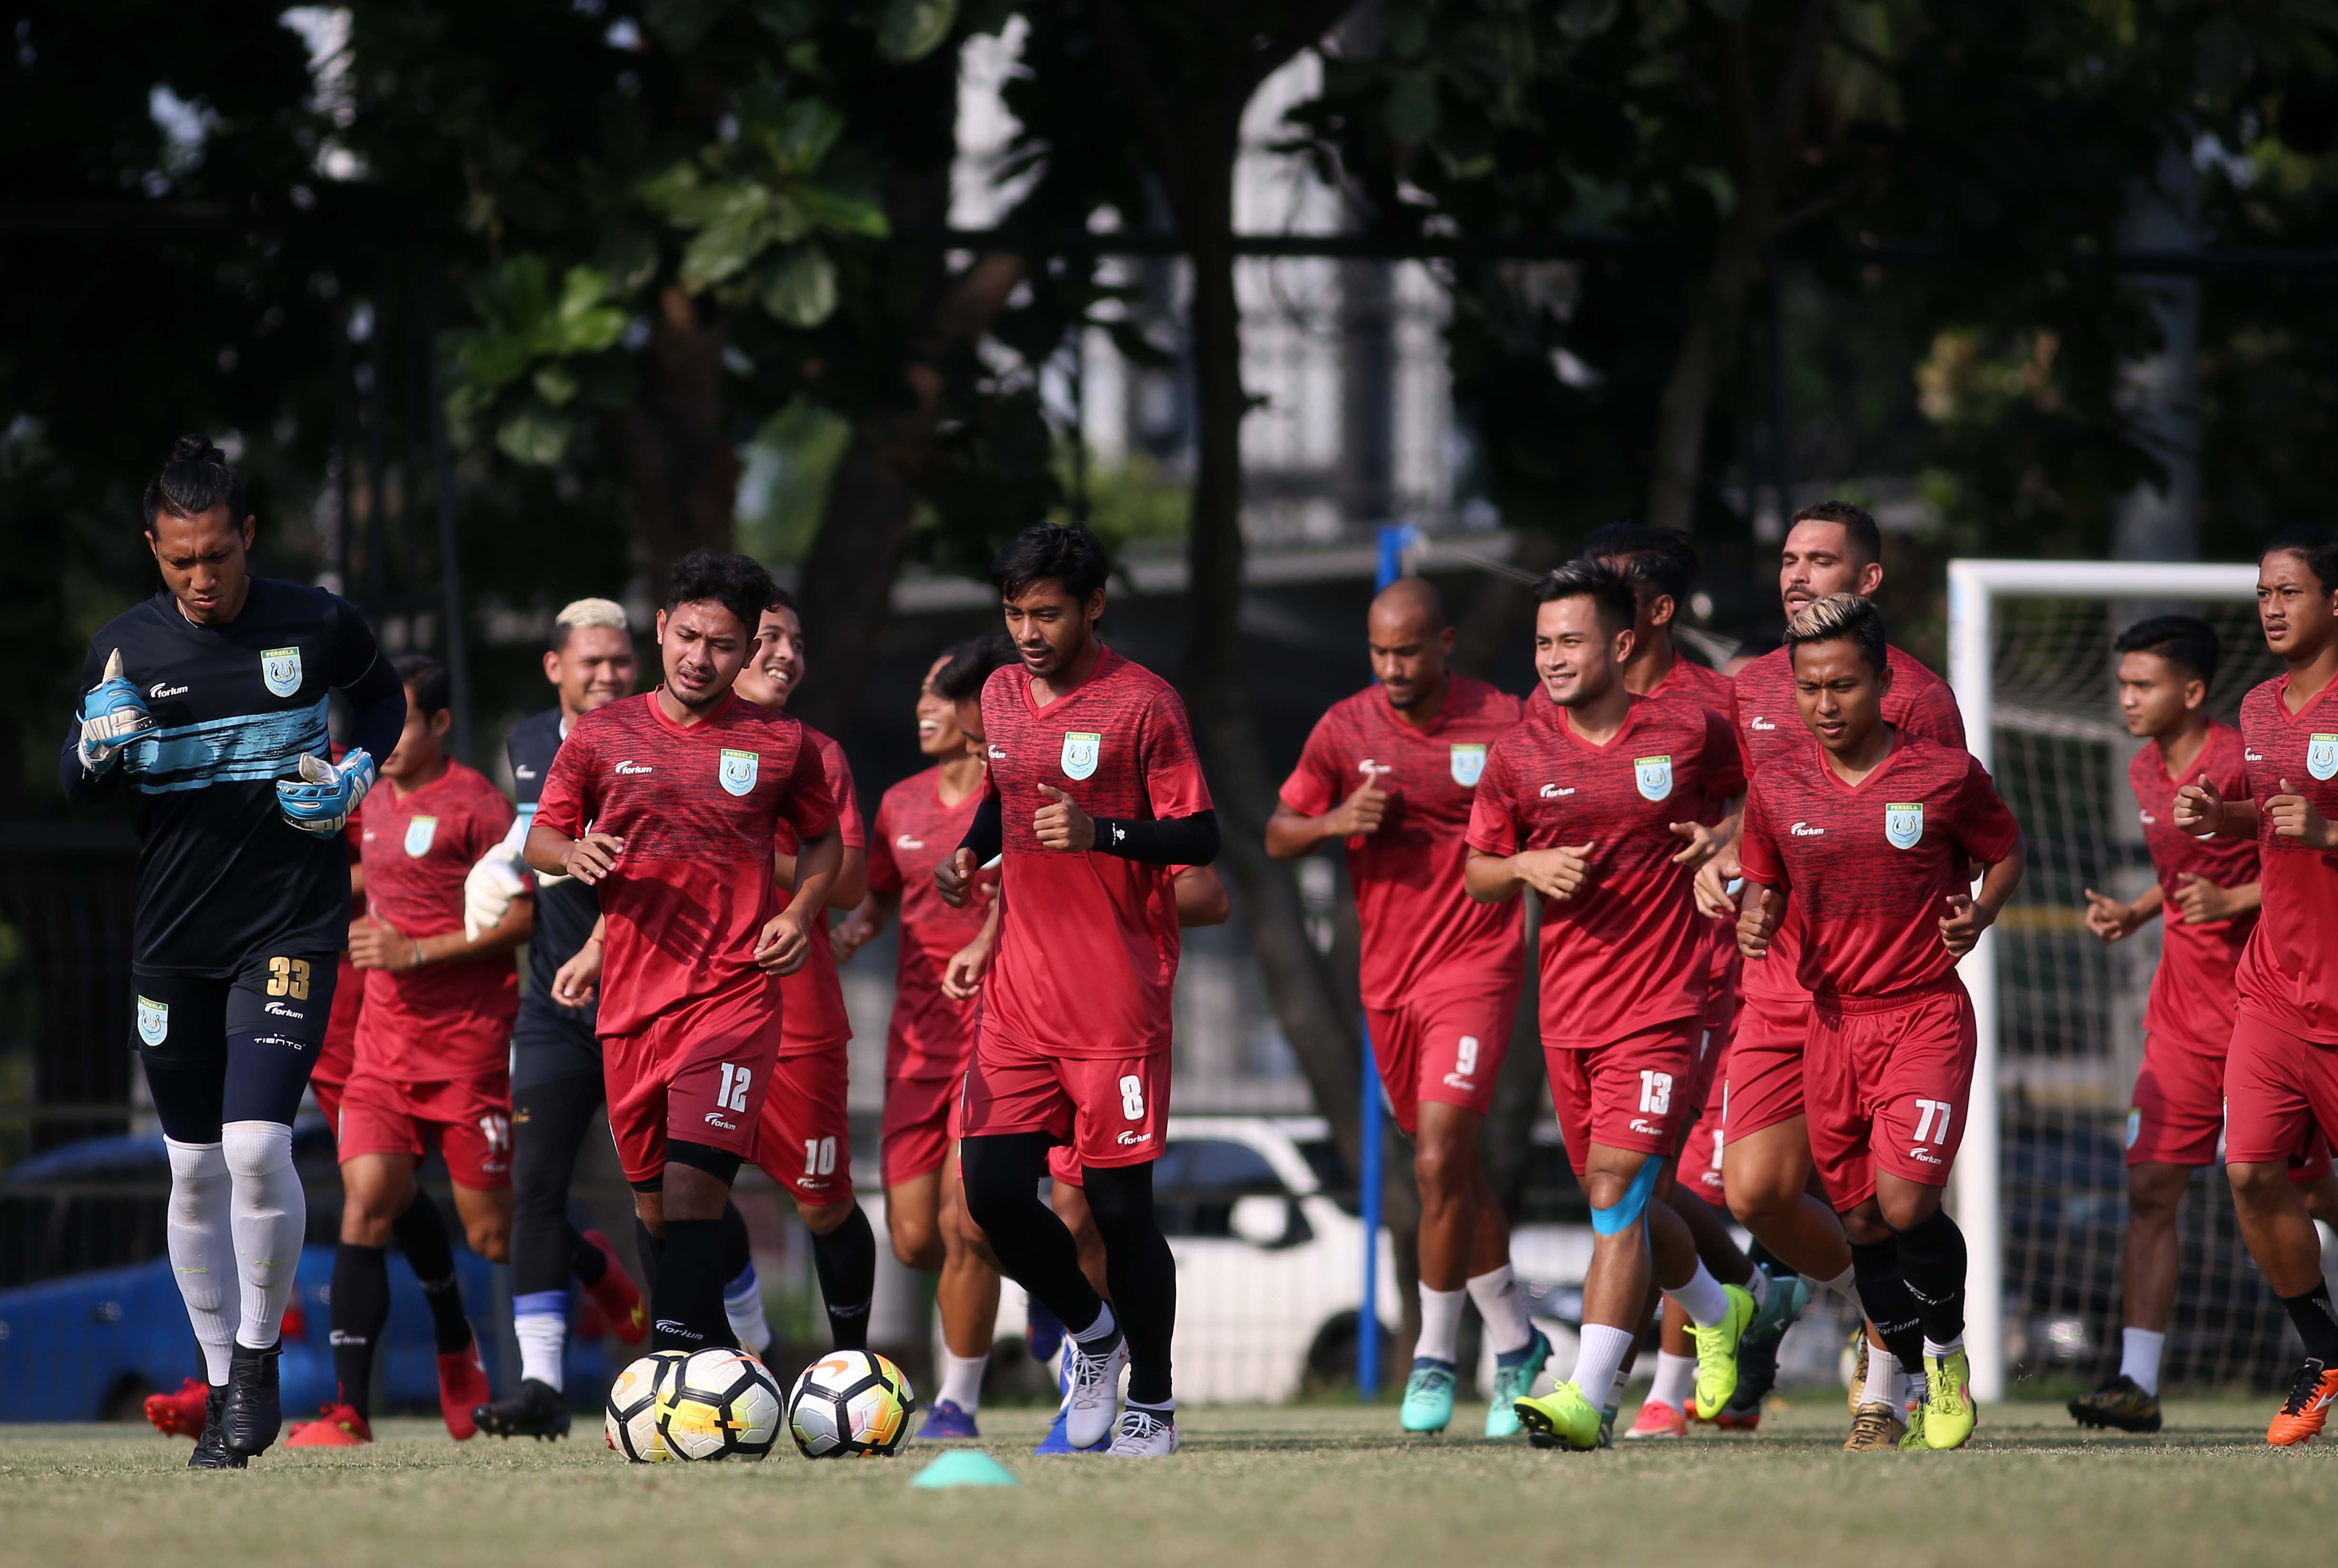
[601,986,778,1189]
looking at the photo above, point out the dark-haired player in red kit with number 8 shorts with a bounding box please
[935,524,1218,1458]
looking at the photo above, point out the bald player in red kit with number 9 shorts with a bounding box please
[1267,577,1550,1437]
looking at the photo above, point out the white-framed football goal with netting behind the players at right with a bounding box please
[1947,561,2287,1397]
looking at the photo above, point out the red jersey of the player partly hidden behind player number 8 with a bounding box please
[870,766,998,1080]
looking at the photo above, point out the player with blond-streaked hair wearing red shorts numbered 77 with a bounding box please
[1737,593,2022,1449]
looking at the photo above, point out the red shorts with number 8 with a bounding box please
[958,1028,1169,1166]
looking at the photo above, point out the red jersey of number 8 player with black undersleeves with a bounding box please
[982,650,1211,1059]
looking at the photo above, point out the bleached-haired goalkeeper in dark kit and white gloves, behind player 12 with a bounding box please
[463,598,654,1440]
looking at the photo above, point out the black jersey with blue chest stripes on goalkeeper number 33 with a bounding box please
[58,577,404,977]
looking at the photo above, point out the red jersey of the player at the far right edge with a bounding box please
[2235,675,2338,1044]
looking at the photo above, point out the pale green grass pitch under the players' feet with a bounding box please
[0,1397,2338,1568]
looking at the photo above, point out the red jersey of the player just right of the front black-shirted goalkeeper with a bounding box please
[355,762,519,1080]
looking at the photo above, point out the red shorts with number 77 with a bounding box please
[1802,977,1980,1211]
